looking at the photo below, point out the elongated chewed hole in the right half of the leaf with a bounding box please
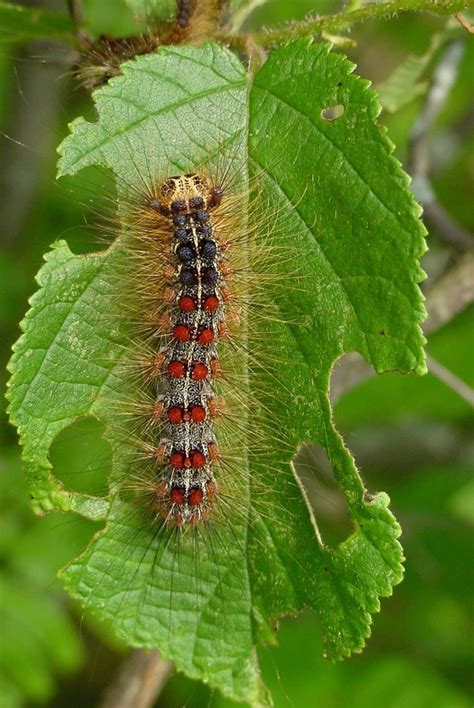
[294,443,354,546]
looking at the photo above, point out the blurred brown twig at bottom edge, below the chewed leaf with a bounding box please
[101,649,173,708]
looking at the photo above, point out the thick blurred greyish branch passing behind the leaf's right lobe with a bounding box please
[331,253,474,403]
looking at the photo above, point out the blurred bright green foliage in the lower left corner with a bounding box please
[0,454,85,708]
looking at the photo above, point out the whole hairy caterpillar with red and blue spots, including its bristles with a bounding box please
[112,156,288,528]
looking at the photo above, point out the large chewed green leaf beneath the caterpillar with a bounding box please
[10,40,425,706]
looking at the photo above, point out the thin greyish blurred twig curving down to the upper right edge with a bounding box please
[408,40,474,252]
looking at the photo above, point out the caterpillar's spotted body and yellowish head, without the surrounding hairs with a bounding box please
[149,174,228,525]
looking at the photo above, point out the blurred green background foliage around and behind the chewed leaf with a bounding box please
[0,0,474,708]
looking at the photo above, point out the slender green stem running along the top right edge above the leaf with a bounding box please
[225,0,473,46]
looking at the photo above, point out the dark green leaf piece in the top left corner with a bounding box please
[0,2,75,44]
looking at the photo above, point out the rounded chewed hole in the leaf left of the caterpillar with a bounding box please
[50,416,112,496]
